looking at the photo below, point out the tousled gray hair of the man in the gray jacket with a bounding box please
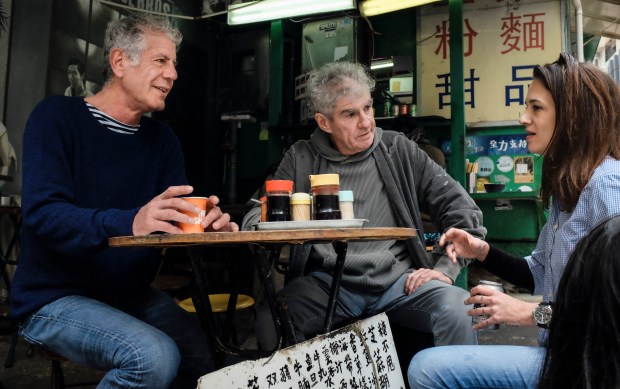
[306,62,375,117]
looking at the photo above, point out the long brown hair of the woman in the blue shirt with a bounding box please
[534,53,620,212]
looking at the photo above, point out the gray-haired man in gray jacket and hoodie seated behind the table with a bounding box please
[243,62,486,349]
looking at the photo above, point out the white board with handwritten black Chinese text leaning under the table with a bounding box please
[198,314,405,389]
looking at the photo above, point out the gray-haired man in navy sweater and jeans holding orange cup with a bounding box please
[10,15,238,389]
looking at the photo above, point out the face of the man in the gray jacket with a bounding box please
[315,85,375,155]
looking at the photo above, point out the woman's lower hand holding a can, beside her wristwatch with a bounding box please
[465,285,537,330]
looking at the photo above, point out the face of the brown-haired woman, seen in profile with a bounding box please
[519,78,555,155]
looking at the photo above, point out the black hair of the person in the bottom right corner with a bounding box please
[539,216,620,389]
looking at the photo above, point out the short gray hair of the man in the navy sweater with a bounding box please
[103,13,183,82]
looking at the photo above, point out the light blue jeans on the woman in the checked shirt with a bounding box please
[407,345,545,389]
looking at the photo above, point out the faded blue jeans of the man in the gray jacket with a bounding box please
[256,272,478,349]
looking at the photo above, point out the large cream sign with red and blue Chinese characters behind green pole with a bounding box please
[417,0,562,123]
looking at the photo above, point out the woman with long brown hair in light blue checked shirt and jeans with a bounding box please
[408,54,620,388]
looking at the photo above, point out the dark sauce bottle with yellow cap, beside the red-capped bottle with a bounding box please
[310,174,341,220]
